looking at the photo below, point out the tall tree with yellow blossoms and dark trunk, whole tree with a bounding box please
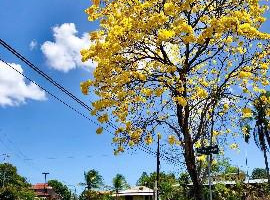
[81,0,270,200]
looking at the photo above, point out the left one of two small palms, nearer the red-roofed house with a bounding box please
[83,169,103,190]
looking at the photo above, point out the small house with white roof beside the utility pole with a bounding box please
[112,186,154,200]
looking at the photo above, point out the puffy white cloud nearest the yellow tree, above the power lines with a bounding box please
[41,23,95,72]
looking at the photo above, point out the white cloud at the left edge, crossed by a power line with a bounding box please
[0,61,46,106]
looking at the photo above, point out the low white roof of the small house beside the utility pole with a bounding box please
[112,186,154,196]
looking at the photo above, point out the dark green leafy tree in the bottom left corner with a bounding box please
[0,163,34,200]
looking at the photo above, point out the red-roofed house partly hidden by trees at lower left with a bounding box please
[31,183,61,200]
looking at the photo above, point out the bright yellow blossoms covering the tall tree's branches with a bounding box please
[81,0,270,153]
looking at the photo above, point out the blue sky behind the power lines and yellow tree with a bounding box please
[0,0,270,194]
